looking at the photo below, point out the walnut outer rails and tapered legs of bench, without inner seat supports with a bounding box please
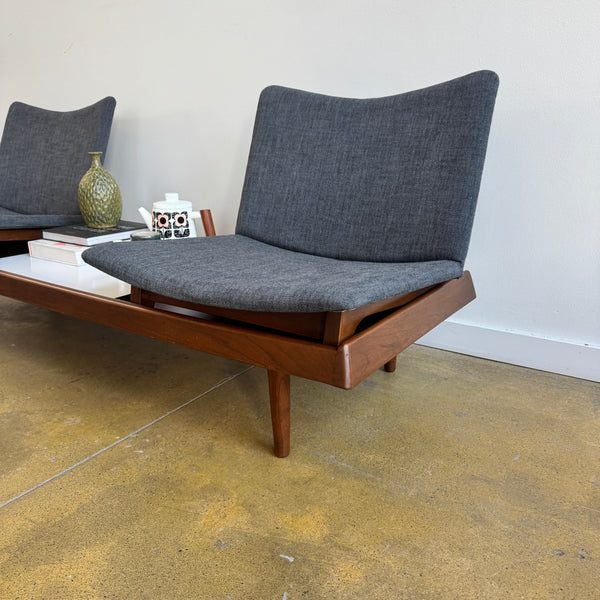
[0,271,475,457]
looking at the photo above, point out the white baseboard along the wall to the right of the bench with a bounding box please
[416,321,600,382]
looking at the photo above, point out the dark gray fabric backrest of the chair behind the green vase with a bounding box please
[0,96,116,215]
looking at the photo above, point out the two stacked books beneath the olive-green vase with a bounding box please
[29,221,147,266]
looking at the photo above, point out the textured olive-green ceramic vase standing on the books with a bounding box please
[77,152,123,229]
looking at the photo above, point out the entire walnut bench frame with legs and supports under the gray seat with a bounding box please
[0,264,475,457]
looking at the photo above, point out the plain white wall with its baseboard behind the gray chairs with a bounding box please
[0,0,600,379]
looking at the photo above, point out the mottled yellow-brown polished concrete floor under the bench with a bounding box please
[0,299,600,600]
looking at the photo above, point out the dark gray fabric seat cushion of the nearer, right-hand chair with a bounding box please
[83,235,462,312]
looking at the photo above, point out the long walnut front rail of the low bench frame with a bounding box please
[0,272,345,387]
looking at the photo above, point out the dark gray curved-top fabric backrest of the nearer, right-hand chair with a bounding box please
[236,71,498,262]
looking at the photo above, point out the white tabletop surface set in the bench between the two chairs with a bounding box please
[0,254,131,298]
